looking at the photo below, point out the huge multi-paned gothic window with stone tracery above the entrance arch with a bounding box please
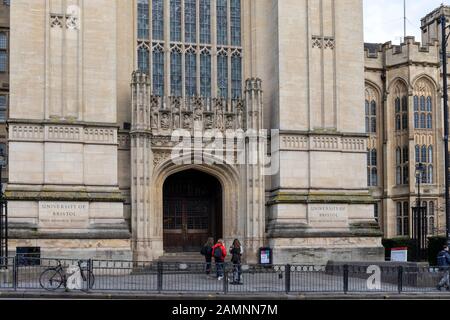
[136,0,244,99]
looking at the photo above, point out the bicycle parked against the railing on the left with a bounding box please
[39,260,95,291]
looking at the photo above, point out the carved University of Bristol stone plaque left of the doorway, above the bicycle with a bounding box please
[39,202,89,229]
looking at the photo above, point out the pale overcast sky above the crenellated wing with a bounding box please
[364,0,450,43]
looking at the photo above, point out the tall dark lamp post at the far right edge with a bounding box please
[441,15,450,244]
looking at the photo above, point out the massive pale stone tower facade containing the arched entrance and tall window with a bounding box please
[7,0,383,263]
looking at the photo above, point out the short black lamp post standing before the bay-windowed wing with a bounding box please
[413,163,428,261]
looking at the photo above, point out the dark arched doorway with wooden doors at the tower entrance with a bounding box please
[163,170,222,252]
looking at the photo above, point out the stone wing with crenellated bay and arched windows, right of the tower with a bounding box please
[364,6,450,238]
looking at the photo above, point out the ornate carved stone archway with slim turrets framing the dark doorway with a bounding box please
[131,72,265,262]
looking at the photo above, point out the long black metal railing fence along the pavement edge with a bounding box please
[0,256,446,294]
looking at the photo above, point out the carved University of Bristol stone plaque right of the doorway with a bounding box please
[308,204,348,229]
